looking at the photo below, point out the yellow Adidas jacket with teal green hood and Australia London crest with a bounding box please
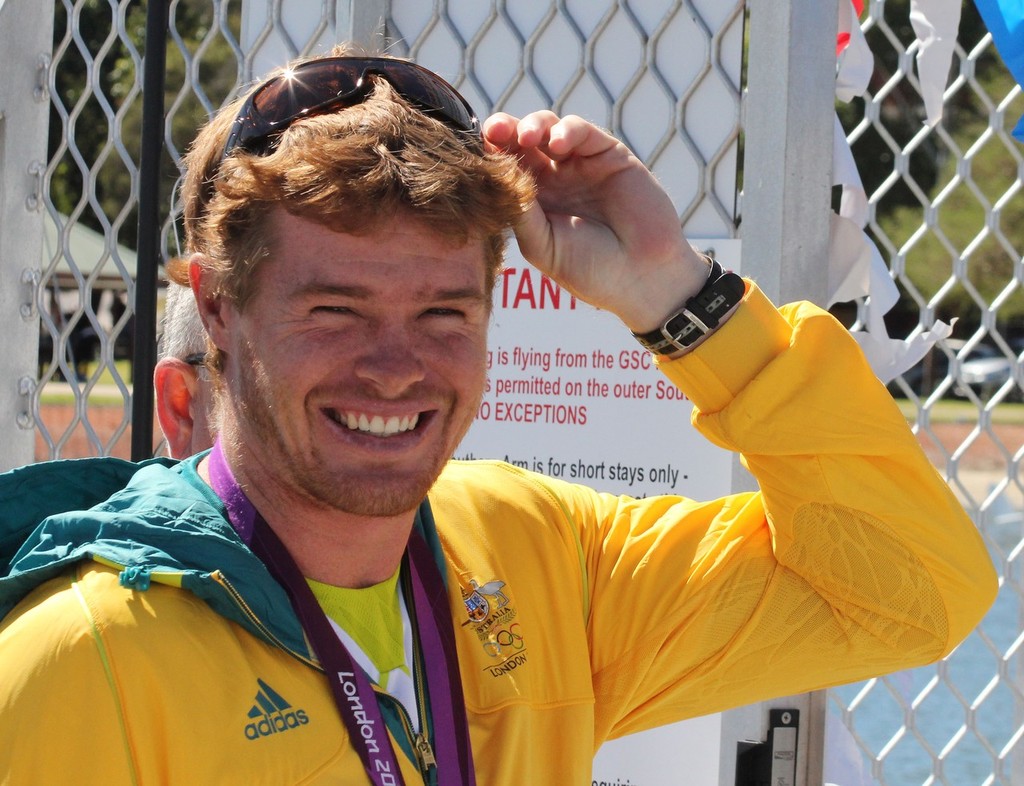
[0,287,996,786]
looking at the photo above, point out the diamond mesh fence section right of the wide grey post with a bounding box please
[830,0,1024,786]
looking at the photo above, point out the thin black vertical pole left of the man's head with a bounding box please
[131,0,170,462]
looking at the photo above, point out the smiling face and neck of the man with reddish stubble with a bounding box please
[198,207,489,586]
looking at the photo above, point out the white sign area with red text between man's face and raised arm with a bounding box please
[456,239,739,498]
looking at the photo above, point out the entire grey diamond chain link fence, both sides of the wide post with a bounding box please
[22,0,1024,786]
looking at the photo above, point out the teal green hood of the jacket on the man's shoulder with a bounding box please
[0,455,310,657]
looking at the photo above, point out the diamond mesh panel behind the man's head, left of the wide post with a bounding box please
[34,0,742,460]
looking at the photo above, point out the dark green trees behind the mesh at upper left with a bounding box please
[49,0,241,254]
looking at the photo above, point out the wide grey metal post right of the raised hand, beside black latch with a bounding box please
[721,0,837,786]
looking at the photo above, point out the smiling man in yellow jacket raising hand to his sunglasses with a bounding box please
[0,49,995,786]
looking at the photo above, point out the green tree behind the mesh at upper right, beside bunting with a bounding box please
[840,0,1024,336]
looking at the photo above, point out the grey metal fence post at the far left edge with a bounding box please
[0,0,53,470]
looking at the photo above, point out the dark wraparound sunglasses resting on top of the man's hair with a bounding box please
[221,57,482,161]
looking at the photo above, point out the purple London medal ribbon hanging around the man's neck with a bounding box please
[209,439,476,786]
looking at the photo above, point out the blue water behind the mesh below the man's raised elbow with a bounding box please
[825,505,1024,786]
